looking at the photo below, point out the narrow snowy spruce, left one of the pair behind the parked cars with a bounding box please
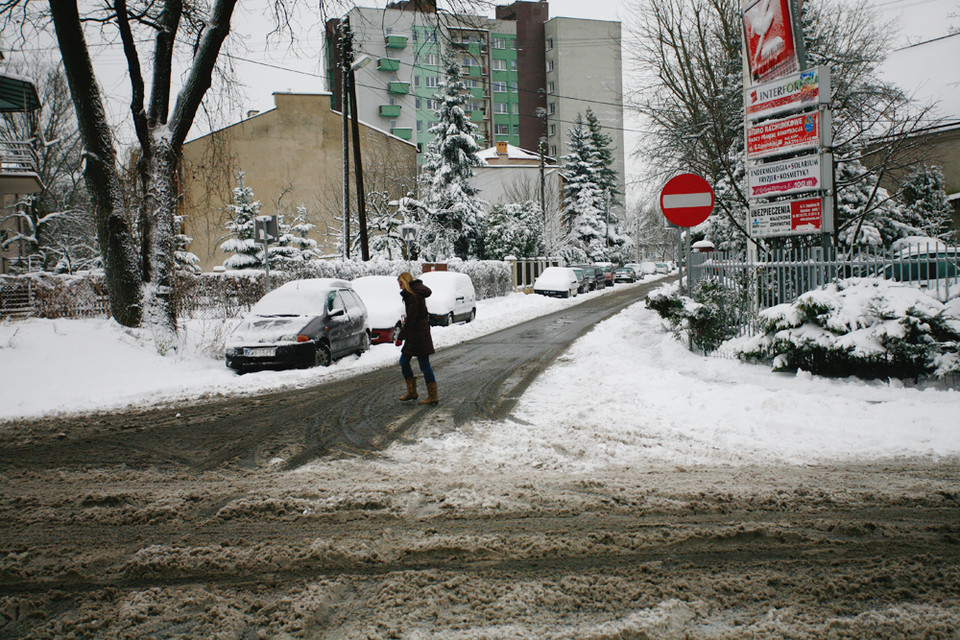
[560,114,607,261]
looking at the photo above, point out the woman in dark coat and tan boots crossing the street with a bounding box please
[396,271,440,404]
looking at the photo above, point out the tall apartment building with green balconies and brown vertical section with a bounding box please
[326,0,624,181]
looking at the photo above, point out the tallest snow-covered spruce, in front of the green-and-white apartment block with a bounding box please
[423,51,485,259]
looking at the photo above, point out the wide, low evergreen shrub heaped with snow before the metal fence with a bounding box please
[725,278,960,378]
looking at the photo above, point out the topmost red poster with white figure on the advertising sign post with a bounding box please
[743,0,800,84]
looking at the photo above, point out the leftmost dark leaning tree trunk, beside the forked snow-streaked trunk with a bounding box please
[50,1,142,327]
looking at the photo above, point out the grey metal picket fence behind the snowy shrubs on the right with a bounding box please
[688,241,960,334]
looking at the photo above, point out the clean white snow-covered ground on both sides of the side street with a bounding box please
[0,276,960,464]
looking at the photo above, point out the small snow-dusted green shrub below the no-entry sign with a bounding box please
[646,278,746,352]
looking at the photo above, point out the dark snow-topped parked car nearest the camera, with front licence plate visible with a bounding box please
[225,278,370,373]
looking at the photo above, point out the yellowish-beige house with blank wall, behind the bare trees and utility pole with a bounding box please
[180,93,417,271]
